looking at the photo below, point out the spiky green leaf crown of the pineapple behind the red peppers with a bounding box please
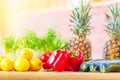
[70,0,92,35]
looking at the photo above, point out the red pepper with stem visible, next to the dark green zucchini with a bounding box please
[65,50,84,71]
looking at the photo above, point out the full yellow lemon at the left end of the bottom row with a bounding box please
[0,58,13,71]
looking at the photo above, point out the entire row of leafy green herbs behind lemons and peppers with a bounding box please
[1,28,68,53]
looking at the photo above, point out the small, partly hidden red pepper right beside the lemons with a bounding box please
[40,52,52,69]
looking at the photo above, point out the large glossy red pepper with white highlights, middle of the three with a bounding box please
[47,50,71,72]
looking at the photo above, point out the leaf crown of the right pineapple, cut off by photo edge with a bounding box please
[105,3,120,38]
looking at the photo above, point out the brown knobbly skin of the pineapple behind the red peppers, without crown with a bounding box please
[68,36,92,61]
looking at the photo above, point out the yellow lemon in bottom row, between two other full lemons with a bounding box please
[14,58,30,72]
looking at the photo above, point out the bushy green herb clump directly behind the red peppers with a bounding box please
[40,28,68,52]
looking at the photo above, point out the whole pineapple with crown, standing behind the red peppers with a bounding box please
[68,0,92,61]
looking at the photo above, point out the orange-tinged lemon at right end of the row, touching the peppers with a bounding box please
[30,58,43,71]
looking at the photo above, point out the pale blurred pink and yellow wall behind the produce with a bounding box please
[0,0,120,53]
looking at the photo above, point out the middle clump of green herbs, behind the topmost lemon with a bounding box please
[20,30,40,50]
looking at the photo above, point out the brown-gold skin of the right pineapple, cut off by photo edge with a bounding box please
[103,39,120,59]
